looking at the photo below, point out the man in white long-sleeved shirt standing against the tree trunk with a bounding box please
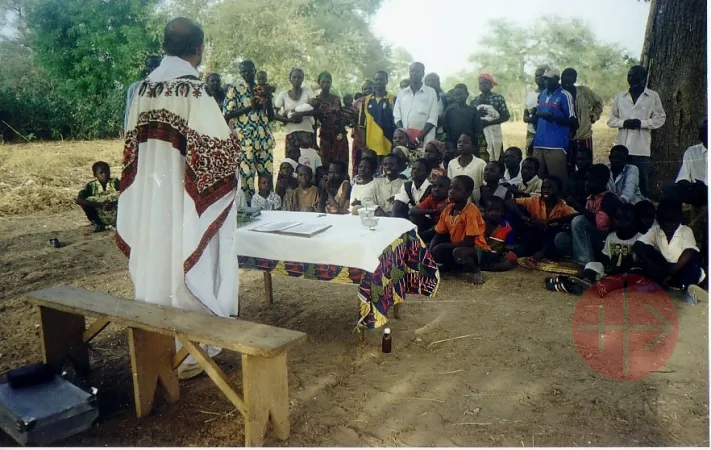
[607,66,667,197]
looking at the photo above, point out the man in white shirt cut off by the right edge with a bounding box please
[664,119,709,206]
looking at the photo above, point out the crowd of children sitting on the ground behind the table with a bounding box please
[251,130,706,302]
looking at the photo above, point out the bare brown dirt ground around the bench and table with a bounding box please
[0,211,709,446]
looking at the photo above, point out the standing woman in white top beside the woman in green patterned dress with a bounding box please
[274,67,316,148]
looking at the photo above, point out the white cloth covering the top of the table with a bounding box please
[235,211,415,272]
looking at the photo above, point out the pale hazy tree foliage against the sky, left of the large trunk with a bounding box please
[445,17,636,119]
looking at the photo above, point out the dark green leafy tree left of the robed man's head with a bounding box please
[27,0,159,97]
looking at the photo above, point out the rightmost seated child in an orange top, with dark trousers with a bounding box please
[506,175,578,263]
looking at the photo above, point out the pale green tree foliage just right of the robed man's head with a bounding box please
[195,0,408,92]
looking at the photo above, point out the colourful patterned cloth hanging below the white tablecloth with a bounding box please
[239,229,439,331]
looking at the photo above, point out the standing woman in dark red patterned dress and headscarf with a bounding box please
[311,72,348,167]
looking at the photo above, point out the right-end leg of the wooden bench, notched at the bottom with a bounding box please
[242,353,289,447]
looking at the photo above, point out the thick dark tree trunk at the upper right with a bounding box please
[642,0,708,198]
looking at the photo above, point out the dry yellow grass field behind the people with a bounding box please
[0,120,615,217]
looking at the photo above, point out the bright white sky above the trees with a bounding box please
[372,0,649,78]
